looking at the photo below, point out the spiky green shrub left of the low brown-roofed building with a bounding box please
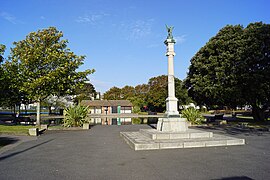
[64,104,89,127]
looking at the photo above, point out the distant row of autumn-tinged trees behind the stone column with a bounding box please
[104,75,191,112]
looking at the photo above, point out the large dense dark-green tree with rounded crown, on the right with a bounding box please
[185,22,270,120]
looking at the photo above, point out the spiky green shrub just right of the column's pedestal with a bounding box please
[182,107,204,124]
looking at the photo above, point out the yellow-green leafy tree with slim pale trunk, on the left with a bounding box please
[9,27,94,124]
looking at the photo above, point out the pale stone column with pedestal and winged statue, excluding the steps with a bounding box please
[157,26,188,132]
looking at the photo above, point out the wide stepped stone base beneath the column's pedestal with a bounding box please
[120,129,245,151]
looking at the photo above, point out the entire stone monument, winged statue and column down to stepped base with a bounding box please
[120,26,245,150]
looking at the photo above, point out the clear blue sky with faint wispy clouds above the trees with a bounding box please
[0,0,270,92]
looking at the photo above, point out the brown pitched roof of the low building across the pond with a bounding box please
[81,100,132,107]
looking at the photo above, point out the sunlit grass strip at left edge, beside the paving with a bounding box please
[0,125,35,135]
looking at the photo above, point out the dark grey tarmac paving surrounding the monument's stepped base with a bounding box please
[0,125,270,180]
